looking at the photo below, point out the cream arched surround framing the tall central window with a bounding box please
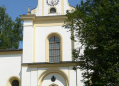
[45,32,63,62]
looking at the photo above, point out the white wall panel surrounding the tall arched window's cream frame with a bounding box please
[35,26,72,62]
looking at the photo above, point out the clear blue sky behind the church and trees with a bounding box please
[0,0,85,49]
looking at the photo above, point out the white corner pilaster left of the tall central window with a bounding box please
[23,20,33,63]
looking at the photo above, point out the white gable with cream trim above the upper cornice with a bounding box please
[31,0,75,16]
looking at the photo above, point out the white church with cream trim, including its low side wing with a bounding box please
[0,0,83,86]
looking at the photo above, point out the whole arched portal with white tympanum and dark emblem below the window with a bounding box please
[38,68,69,86]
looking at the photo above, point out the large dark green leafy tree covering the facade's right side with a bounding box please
[64,0,119,86]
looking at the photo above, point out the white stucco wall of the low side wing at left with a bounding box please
[0,54,22,86]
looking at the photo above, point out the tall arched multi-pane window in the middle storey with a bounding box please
[49,36,60,62]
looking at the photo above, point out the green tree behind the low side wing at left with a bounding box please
[0,6,22,49]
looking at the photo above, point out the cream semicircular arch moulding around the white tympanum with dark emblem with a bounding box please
[38,68,69,86]
